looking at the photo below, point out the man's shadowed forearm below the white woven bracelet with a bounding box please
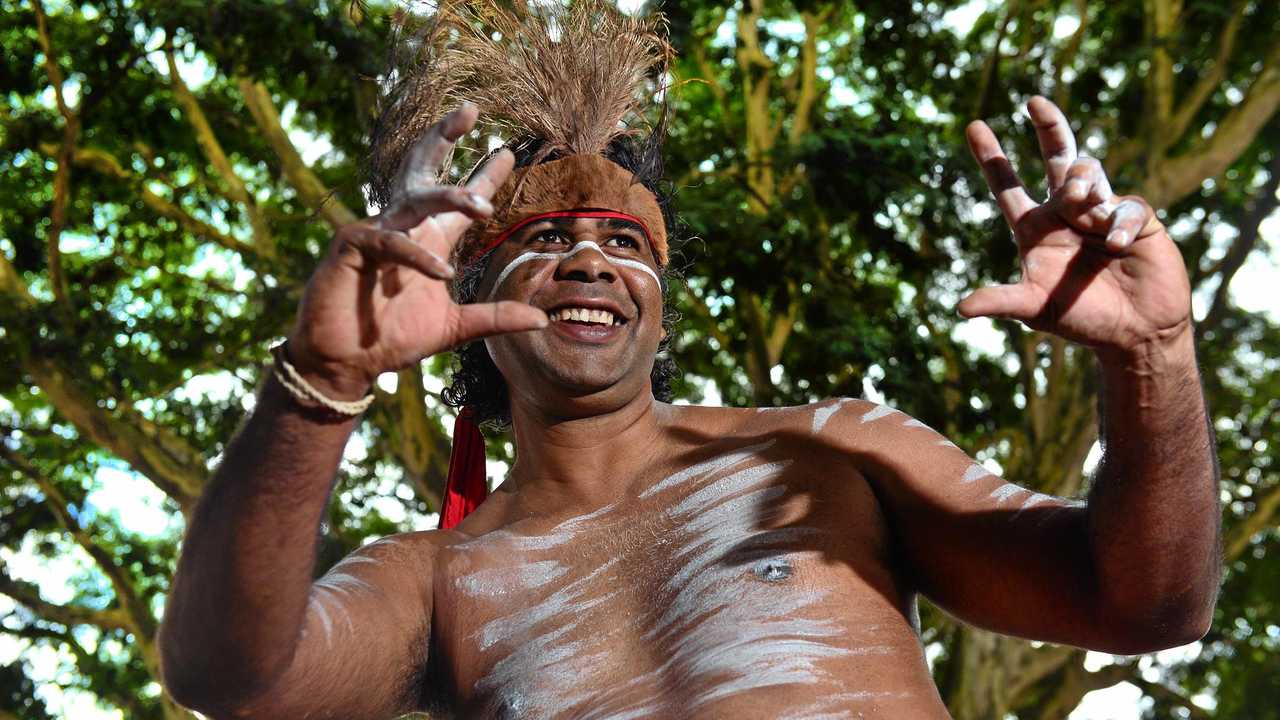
[161,377,356,697]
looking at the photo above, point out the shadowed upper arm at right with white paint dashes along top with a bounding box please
[823,401,1111,650]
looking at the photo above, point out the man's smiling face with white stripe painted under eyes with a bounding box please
[477,212,662,405]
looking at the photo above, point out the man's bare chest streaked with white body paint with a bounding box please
[433,446,918,717]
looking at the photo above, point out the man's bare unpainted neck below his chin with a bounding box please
[508,392,668,509]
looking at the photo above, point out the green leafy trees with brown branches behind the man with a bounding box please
[0,0,1280,719]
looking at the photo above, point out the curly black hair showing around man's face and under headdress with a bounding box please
[442,132,680,430]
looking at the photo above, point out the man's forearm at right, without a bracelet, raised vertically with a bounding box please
[1089,329,1220,642]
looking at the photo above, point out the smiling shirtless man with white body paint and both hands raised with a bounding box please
[161,2,1219,720]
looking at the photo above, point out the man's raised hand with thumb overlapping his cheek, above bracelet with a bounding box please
[289,105,548,400]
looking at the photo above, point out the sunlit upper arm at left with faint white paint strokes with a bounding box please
[240,533,439,720]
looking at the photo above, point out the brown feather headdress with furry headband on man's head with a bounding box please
[370,0,672,265]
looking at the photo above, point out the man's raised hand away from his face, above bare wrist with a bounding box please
[959,96,1190,352]
